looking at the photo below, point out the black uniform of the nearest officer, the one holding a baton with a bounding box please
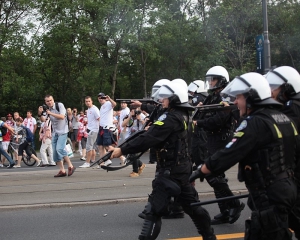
[205,108,298,240]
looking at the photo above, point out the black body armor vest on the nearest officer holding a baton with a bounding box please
[239,109,298,188]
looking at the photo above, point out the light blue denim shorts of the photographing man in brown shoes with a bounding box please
[52,133,68,162]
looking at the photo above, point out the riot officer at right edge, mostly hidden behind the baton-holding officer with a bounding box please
[266,66,300,239]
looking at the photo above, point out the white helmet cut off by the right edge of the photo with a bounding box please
[266,66,300,100]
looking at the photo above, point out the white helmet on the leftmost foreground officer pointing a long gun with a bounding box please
[155,81,194,110]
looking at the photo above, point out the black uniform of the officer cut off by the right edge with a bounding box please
[281,100,300,239]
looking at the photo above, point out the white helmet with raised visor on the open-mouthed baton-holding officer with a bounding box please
[221,72,281,108]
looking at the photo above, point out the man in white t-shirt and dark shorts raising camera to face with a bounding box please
[97,93,117,165]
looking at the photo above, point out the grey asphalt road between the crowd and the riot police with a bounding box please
[0,153,296,240]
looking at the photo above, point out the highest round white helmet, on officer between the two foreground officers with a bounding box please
[205,66,229,90]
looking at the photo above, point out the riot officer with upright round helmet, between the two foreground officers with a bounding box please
[194,66,245,225]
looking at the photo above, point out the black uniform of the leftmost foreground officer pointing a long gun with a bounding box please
[121,107,215,240]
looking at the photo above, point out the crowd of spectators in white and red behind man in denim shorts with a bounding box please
[0,93,148,177]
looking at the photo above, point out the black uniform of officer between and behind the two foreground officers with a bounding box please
[197,92,245,224]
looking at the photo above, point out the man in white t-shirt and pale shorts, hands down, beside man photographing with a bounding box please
[79,96,100,168]
